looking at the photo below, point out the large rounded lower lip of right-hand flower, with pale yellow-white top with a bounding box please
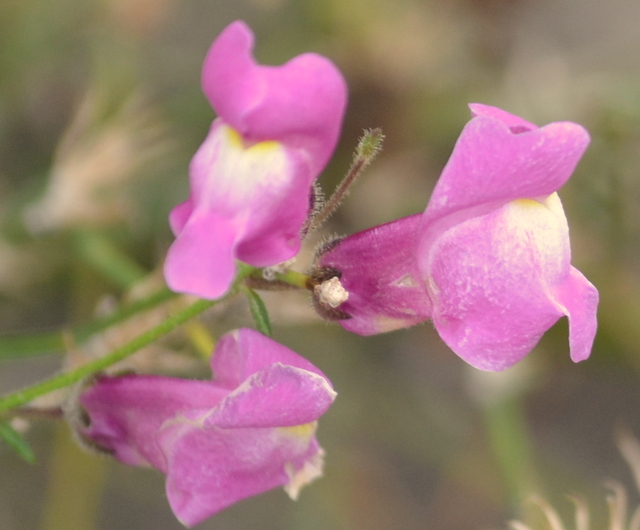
[420,196,570,371]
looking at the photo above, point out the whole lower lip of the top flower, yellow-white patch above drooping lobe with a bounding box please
[165,113,322,298]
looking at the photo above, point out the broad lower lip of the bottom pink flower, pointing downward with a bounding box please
[158,416,321,526]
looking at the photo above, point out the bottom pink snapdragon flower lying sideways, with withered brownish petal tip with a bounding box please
[80,329,336,526]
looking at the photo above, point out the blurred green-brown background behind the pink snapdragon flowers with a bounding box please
[0,0,640,530]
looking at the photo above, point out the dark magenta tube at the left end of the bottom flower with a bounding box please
[80,375,227,470]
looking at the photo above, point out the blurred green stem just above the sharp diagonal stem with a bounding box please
[0,287,176,360]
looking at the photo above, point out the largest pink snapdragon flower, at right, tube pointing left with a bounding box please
[317,104,598,371]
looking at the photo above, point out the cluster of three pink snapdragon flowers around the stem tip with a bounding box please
[80,18,598,525]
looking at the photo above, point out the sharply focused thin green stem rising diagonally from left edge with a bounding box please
[0,289,216,413]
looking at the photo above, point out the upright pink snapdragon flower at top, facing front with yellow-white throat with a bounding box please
[165,22,347,299]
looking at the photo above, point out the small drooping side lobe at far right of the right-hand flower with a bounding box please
[556,267,598,362]
